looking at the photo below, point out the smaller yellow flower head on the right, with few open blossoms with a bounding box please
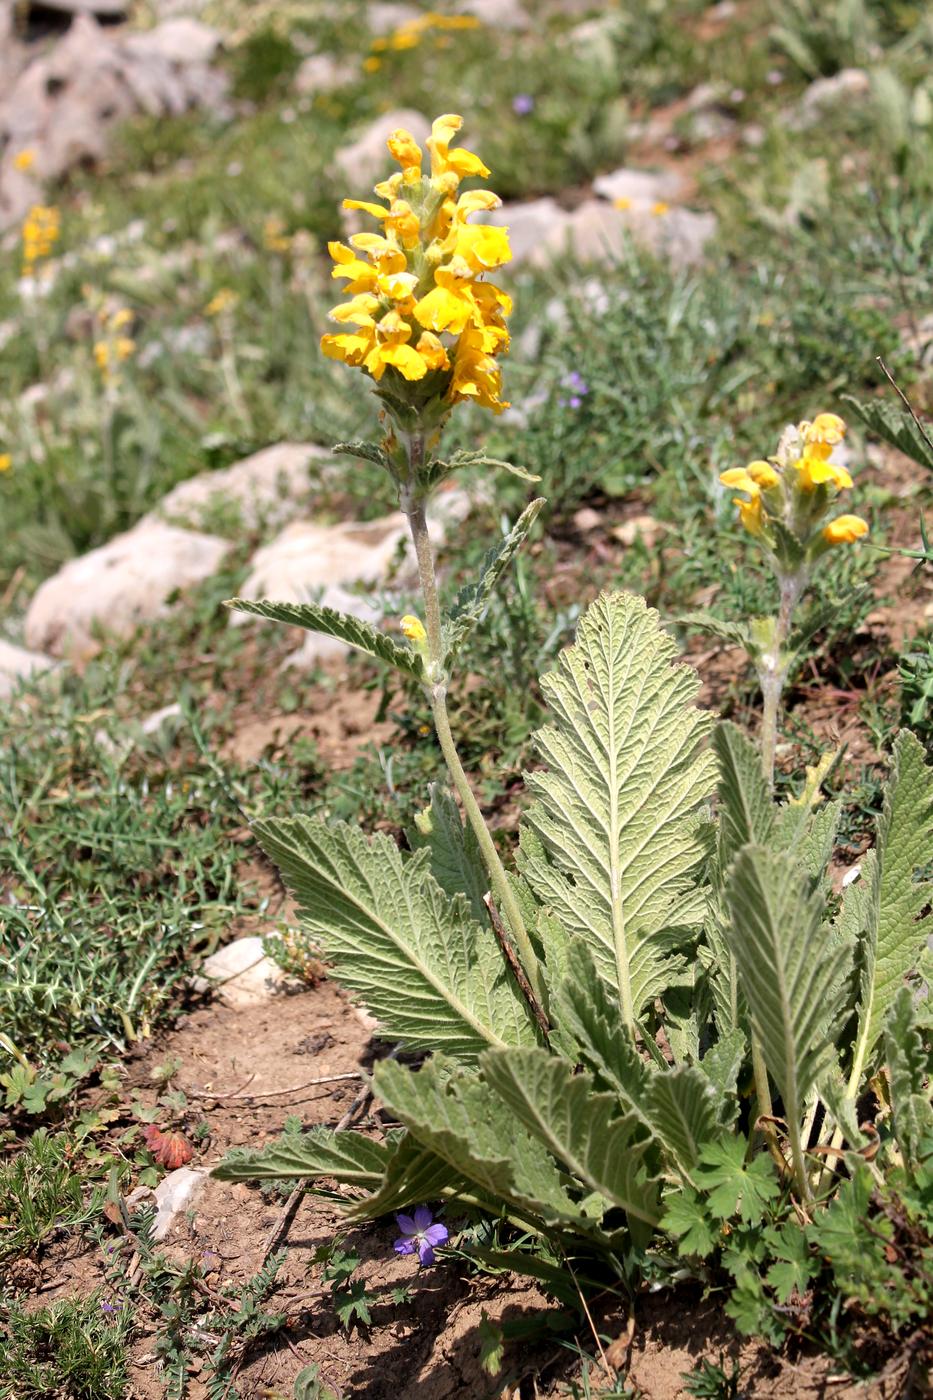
[720,413,869,573]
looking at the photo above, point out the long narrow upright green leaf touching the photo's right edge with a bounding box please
[849,729,933,1098]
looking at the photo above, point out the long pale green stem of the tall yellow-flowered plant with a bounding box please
[399,433,548,1009]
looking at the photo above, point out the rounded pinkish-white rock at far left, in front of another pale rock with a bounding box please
[25,521,230,657]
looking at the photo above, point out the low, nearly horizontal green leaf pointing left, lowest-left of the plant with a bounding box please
[212,1127,392,1190]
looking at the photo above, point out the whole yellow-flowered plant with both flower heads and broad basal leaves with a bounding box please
[216,118,933,1355]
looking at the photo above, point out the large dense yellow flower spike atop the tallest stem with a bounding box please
[321,115,511,428]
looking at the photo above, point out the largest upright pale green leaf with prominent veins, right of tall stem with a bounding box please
[521,594,716,1028]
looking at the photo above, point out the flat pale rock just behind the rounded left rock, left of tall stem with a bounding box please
[144,442,332,529]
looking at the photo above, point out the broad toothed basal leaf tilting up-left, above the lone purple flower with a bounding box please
[373,1054,594,1233]
